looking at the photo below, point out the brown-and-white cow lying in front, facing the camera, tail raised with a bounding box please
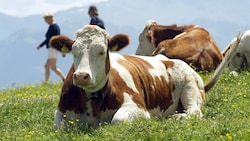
[50,25,238,128]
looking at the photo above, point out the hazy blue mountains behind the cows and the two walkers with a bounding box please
[0,0,247,88]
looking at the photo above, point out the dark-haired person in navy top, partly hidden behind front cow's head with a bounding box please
[88,5,105,29]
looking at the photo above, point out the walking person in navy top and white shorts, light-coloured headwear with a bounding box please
[37,13,65,83]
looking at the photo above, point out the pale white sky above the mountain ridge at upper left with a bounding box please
[0,0,108,17]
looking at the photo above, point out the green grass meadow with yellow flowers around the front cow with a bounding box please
[0,71,250,141]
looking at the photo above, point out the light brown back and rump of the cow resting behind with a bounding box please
[154,27,222,71]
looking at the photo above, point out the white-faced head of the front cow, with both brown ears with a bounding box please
[50,25,129,92]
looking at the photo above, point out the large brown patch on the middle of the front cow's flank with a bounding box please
[115,56,174,110]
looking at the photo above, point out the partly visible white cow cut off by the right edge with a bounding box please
[222,30,250,76]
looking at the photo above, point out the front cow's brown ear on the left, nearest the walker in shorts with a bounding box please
[49,35,74,53]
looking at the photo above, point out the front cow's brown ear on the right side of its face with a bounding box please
[109,34,130,51]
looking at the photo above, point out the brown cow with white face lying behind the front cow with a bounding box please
[136,20,223,71]
